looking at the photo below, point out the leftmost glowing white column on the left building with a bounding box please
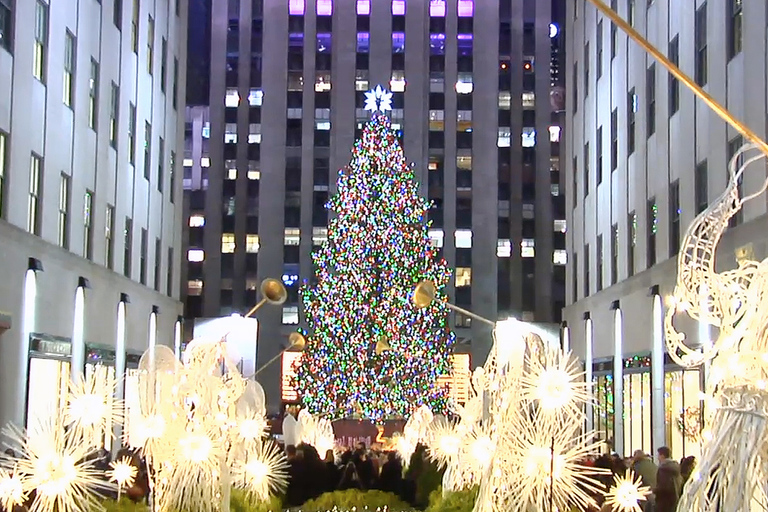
[17,258,43,423]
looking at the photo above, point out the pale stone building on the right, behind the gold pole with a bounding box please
[564,0,768,458]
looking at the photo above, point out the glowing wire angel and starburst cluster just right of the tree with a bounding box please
[420,320,606,512]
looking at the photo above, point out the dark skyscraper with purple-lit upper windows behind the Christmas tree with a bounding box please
[184,0,566,406]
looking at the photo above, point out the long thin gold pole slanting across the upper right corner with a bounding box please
[587,0,768,155]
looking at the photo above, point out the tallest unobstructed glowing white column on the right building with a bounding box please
[651,285,666,451]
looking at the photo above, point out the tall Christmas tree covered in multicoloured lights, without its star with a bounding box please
[294,113,455,421]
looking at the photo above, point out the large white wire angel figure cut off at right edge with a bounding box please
[665,144,768,512]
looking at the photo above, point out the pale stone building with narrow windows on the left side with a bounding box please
[0,0,186,425]
